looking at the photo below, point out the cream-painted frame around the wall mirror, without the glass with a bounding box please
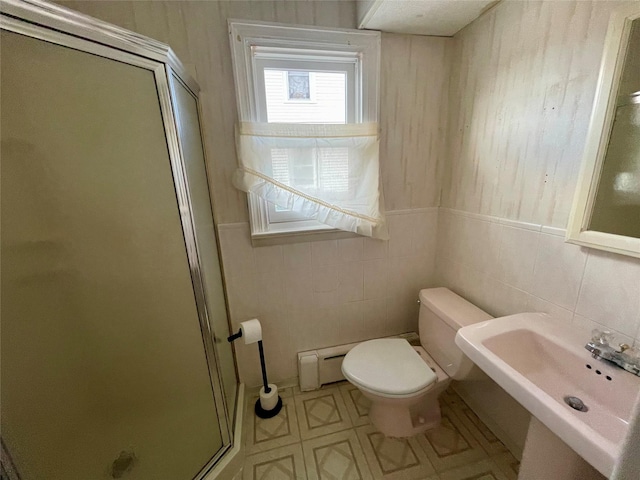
[565,2,640,258]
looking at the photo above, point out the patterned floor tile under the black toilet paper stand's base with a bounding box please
[245,397,300,455]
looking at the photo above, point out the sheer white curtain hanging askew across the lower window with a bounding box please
[234,123,388,239]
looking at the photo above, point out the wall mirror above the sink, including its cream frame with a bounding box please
[566,3,640,257]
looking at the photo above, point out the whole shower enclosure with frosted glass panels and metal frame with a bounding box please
[0,0,237,480]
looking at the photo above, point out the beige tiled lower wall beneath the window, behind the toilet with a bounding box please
[220,208,438,386]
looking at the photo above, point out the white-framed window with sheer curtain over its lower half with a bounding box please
[229,21,385,242]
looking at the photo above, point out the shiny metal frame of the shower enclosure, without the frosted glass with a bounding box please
[0,0,233,480]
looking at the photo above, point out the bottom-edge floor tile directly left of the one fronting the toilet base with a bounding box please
[302,429,373,480]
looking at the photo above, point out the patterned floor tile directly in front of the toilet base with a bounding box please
[356,425,434,480]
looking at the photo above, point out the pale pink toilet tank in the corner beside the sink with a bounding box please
[418,288,493,380]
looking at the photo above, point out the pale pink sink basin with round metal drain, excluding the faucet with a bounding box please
[456,313,640,477]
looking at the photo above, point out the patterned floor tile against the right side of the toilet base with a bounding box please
[418,404,488,472]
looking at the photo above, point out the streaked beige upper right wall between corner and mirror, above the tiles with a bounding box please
[442,1,629,228]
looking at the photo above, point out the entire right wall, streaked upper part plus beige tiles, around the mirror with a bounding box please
[437,1,640,339]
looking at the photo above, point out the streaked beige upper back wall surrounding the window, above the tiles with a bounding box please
[57,0,451,224]
